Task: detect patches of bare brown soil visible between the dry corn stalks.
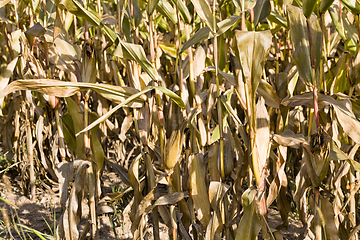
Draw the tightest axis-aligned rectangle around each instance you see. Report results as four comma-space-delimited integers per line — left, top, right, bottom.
0, 168, 303, 240
